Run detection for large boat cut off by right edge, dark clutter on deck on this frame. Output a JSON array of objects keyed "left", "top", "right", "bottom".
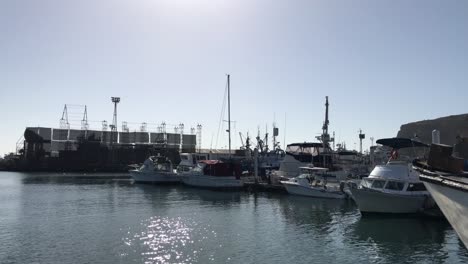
[{"left": 414, "top": 144, "right": 468, "bottom": 248}]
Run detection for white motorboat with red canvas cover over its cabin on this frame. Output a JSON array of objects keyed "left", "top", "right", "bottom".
[{"left": 180, "top": 160, "right": 243, "bottom": 189}]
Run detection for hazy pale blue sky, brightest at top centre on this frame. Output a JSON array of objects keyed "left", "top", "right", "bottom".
[{"left": 0, "top": 0, "right": 468, "bottom": 154}]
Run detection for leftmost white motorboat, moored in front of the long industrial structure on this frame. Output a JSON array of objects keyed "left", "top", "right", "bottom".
[{"left": 129, "top": 156, "right": 181, "bottom": 183}]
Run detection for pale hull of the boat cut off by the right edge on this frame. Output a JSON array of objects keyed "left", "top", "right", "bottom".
[{"left": 424, "top": 178, "right": 468, "bottom": 248}]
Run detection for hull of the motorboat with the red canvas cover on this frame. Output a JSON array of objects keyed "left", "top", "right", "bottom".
[{"left": 182, "top": 175, "right": 244, "bottom": 189}]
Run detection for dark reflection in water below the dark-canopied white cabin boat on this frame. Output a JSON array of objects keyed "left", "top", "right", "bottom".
[{"left": 347, "top": 216, "right": 463, "bottom": 263}]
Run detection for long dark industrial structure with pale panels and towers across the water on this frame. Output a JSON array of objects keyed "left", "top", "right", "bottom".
[{"left": 17, "top": 97, "right": 201, "bottom": 171}]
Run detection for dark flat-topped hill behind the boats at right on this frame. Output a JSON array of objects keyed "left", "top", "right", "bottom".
[{"left": 397, "top": 114, "right": 468, "bottom": 145}]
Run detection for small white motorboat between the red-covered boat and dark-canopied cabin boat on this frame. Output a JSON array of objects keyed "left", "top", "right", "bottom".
[{"left": 281, "top": 167, "right": 347, "bottom": 199}]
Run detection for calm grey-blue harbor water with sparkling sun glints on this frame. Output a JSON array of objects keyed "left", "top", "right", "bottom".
[{"left": 0, "top": 172, "right": 468, "bottom": 263}]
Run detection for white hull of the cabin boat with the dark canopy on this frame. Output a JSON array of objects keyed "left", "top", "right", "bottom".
[{"left": 351, "top": 188, "right": 431, "bottom": 214}]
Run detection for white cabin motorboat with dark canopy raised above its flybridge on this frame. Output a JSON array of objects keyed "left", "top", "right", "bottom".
[{"left": 351, "top": 138, "right": 435, "bottom": 214}]
